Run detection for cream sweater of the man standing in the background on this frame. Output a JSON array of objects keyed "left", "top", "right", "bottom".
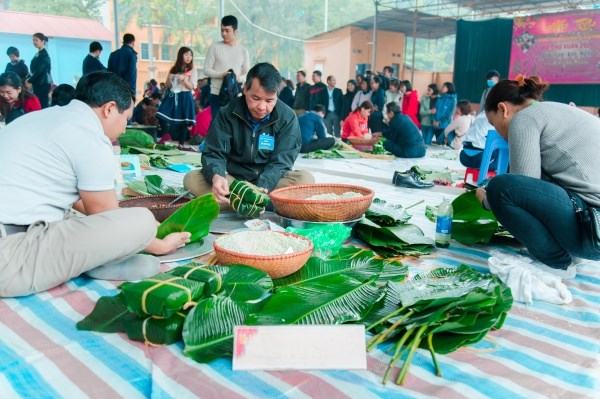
[{"left": 204, "top": 41, "right": 250, "bottom": 95}]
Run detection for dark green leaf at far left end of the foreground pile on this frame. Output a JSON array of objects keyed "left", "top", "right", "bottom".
[{"left": 77, "top": 293, "right": 136, "bottom": 332}]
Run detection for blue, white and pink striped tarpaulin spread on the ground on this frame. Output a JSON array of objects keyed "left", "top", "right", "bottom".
[{"left": 0, "top": 152, "right": 600, "bottom": 399}]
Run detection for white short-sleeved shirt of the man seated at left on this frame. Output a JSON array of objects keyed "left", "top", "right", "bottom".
[{"left": 0, "top": 100, "right": 115, "bottom": 225}]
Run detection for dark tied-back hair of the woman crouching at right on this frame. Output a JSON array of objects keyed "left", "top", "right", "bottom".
[{"left": 485, "top": 75, "right": 550, "bottom": 112}]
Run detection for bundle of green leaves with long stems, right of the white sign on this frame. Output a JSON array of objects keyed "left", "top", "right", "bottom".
[{"left": 365, "top": 265, "right": 513, "bottom": 385}]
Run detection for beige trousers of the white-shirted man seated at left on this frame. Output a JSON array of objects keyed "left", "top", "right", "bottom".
[{"left": 0, "top": 208, "right": 157, "bottom": 297}]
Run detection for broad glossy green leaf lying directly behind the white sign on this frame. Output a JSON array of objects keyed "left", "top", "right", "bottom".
[{"left": 247, "top": 275, "right": 380, "bottom": 325}]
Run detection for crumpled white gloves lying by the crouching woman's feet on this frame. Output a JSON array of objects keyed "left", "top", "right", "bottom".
[{"left": 488, "top": 251, "right": 576, "bottom": 305}]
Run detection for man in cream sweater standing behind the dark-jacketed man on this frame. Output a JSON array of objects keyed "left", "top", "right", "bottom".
[{"left": 204, "top": 15, "right": 250, "bottom": 119}]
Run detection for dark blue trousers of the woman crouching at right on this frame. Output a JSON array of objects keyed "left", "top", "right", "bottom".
[{"left": 486, "top": 174, "right": 600, "bottom": 269}]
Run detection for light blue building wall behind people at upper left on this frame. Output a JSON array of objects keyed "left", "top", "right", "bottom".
[{"left": 0, "top": 33, "right": 111, "bottom": 85}]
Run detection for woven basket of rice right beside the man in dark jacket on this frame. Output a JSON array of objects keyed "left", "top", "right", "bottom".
[{"left": 269, "top": 184, "right": 375, "bottom": 222}]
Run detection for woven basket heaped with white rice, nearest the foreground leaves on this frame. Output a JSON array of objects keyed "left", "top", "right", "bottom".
[{"left": 213, "top": 233, "right": 313, "bottom": 278}]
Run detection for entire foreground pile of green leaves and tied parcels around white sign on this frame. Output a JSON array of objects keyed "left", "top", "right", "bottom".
[{"left": 77, "top": 247, "right": 512, "bottom": 382}]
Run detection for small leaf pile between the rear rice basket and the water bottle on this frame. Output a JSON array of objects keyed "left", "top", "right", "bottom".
[{"left": 352, "top": 198, "right": 434, "bottom": 257}]
